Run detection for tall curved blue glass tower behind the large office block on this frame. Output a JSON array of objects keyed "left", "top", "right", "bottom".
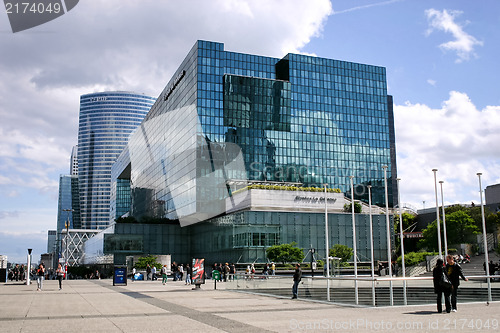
[{"left": 78, "top": 91, "right": 156, "bottom": 229}]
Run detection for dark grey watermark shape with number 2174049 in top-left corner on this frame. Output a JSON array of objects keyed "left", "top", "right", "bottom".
[{"left": 3, "top": 0, "right": 79, "bottom": 33}]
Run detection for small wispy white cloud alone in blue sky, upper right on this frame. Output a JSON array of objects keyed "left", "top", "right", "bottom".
[{"left": 425, "top": 9, "right": 483, "bottom": 63}]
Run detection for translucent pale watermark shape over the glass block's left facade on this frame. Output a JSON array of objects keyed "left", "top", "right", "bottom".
[{"left": 129, "top": 105, "right": 247, "bottom": 226}]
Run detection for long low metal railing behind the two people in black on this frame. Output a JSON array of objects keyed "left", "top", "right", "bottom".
[{"left": 224, "top": 274, "right": 500, "bottom": 307}]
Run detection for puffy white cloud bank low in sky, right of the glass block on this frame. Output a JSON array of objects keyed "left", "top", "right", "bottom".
[{"left": 395, "top": 91, "right": 500, "bottom": 208}]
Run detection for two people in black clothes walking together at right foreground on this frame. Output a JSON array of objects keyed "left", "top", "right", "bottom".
[{"left": 432, "top": 255, "right": 468, "bottom": 313}]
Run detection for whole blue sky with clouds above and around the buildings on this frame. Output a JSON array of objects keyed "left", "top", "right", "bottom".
[{"left": 0, "top": 0, "right": 500, "bottom": 262}]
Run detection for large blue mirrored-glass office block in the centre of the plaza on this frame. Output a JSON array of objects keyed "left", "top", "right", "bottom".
[{"left": 107, "top": 41, "right": 397, "bottom": 261}]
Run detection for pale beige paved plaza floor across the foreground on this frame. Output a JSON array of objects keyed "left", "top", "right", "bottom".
[{"left": 0, "top": 280, "right": 500, "bottom": 332}]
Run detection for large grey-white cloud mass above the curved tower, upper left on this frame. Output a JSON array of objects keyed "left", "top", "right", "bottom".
[{"left": 0, "top": 0, "right": 332, "bottom": 194}]
